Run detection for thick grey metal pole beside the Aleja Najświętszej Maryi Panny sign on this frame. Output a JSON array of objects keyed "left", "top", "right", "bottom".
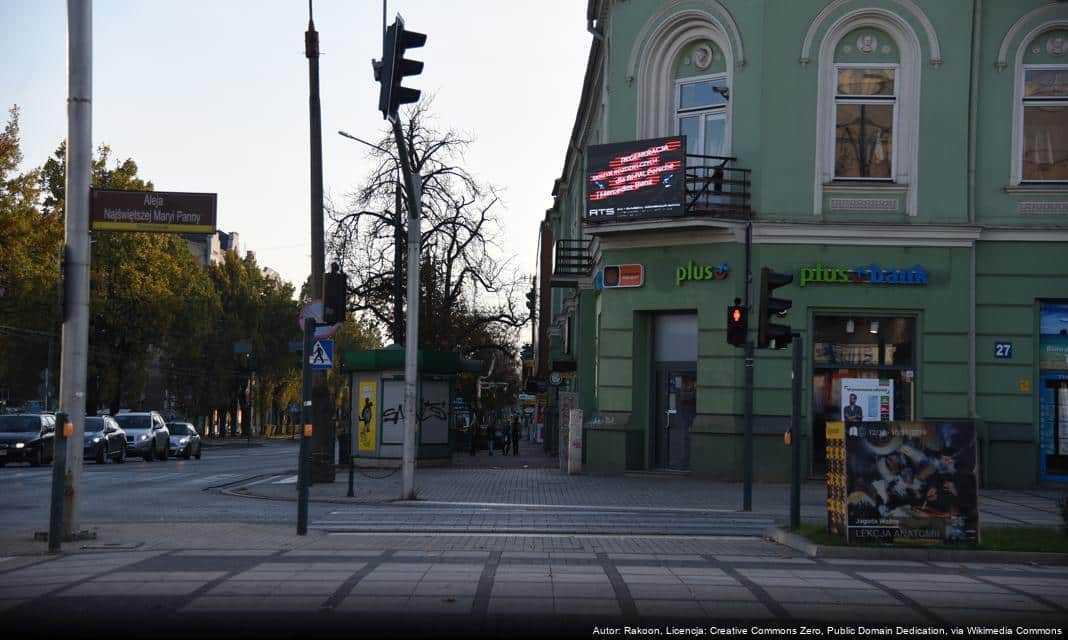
[{"left": 60, "top": 0, "right": 93, "bottom": 537}]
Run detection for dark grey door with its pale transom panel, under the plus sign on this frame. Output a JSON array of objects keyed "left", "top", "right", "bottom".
[{"left": 648, "top": 313, "right": 697, "bottom": 469}]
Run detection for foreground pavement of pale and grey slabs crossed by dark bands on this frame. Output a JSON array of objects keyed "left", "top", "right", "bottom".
[{"left": 0, "top": 529, "right": 1068, "bottom": 637}]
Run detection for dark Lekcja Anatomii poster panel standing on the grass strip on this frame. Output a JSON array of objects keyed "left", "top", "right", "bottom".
[{"left": 844, "top": 422, "right": 979, "bottom": 544}]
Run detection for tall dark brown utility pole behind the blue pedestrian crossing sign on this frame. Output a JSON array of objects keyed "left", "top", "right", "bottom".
[{"left": 303, "top": 0, "right": 334, "bottom": 482}]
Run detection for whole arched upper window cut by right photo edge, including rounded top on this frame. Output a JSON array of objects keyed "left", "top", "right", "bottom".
[{"left": 1014, "top": 29, "right": 1068, "bottom": 183}]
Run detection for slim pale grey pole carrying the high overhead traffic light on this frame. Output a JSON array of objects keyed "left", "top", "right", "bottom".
[{"left": 390, "top": 113, "right": 422, "bottom": 500}]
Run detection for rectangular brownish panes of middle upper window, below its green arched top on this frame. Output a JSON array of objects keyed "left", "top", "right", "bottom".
[{"left": 834, "top": 64, "right": 897, "bottom": 181}]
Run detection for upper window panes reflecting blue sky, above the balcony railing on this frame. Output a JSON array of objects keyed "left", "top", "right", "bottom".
[{"left": 675, "top": 76, "right": 727, "bottom": 161}]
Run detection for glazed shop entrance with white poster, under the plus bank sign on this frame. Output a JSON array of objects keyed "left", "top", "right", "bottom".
[{"left": 812, "top": 315, "right": 916, "bottom": 474}]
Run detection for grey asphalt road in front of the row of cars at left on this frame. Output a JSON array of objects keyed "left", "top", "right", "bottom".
[{"left": 0, "top": 442, "right": 329, "bottom": 531}]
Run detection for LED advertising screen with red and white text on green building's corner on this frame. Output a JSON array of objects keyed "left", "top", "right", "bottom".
[{"left": 586, "top": 136, "right": 686, "bottom": 222}]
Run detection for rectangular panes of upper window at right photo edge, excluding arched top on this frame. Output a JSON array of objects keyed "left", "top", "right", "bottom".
[{"left": 1020, "top": 65, "right": 1068, "bottom": 182}]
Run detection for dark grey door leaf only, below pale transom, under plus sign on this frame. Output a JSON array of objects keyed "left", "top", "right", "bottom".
[{"left": 653, "top": 365, "right": 697, "bottom": 469}]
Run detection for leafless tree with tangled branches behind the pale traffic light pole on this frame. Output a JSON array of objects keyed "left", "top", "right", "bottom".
[{"left": 328, "top": 100, "right": 530, "bottom": 357}]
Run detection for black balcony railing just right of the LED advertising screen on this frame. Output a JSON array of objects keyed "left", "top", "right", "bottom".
[{"left": 686, "top": 154, "right": 752, "bottom": 219}]
